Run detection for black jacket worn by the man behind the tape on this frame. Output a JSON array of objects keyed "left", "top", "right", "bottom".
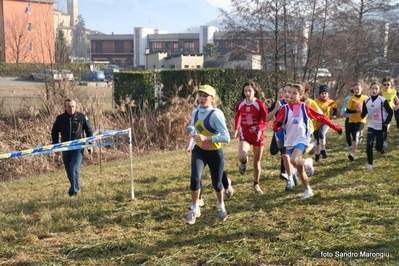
[{"left": 51, "top": 112, "right": 93, "bottom": 144}]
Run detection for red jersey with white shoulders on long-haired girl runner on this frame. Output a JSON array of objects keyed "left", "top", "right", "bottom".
[{"left": 234, "top": 98, "right": 268, "bottom": 134}]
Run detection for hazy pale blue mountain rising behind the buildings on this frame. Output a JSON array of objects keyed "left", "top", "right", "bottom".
[{"left": 78, "top": 0, "right": 225, "bottom": 34}]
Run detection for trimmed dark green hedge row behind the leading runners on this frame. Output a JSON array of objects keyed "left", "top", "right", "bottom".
[{"left": 114, "top": 68, "right": 276, "bottom": 116}]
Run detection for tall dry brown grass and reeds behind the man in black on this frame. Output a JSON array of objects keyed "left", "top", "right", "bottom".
[{"left": 0, "top": 83, "right": 198, "bottom": 181}]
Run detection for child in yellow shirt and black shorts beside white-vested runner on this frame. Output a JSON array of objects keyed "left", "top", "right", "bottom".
[{"left": 346, "top": 83, "right": 367, "bottom": 161}]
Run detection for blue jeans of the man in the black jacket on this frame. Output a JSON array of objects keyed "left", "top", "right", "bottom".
[{"left": 62, "top": 149, "right": 84, "bottom": 196}]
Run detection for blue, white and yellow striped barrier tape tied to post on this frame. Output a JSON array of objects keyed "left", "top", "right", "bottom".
[{"left": 0, "top": 129, "right": 129, "bottom": 160}]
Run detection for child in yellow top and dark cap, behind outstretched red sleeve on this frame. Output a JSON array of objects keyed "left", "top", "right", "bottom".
[{"left": 314, "top": 85, "right": 338, "bottom": 162}]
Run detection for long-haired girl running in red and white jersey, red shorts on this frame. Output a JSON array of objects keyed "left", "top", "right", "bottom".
[{"left": 232, "top": 81, "right": 268, "bottom": 194}]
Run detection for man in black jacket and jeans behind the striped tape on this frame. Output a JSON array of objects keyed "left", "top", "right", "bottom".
[{"left": 51, "top": 99, "right": 93, "bottom": 198}]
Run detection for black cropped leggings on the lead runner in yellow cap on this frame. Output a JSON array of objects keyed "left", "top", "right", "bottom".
[{"left": 190, "top": 146, "right": 227, "bottom": 192}]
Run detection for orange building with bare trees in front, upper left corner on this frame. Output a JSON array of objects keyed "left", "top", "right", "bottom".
[{"left": 0, "top": 0, "right": 55, "bottom": 64}]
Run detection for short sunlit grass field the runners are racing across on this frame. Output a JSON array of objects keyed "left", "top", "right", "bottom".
[{"left": 0, "top": 119, "right": 399, "bottom": 265}]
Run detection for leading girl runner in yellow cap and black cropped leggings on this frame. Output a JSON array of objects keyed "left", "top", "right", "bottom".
[{"left": 186, "top": 85, "right": 230, "bottom": 225}]
